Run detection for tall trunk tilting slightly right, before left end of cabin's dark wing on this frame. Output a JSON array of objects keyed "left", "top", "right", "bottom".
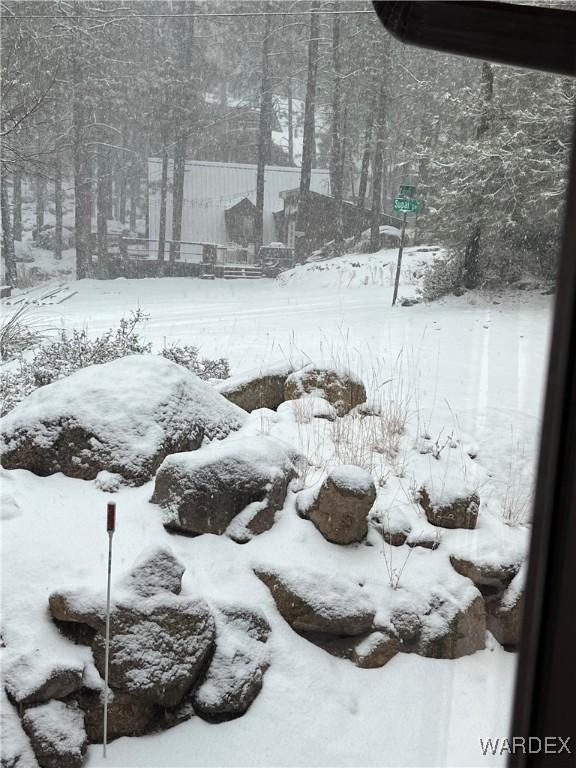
[{"left": 296, "top": 0, "right": 320, "bottom": 259}]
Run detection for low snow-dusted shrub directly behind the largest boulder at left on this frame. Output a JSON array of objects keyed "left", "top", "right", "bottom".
[{"left": 0, "top": 309, "right": 230, "bottom": 415}]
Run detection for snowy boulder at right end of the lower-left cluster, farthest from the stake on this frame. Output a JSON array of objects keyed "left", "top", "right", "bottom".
[{"left": 192, "top": 606, "right": 270, "bottom": 721}]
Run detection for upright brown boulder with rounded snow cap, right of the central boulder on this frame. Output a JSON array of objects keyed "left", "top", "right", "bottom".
[{"left": 307, "top": 465, "right": 376, "bottom": 544}]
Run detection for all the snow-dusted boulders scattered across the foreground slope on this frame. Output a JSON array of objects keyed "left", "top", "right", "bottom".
[{"left": 0, "top": 356, "right": 523, "bottom": 768}]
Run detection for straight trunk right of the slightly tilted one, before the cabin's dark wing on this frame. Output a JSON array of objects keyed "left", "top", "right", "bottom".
[{"left": 330, "top": 4, "right": 344, "bottom": 253}]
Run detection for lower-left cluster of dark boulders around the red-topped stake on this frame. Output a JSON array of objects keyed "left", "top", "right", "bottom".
[{"left": 5, "top": 549, "right": 270, "bottom": 768}]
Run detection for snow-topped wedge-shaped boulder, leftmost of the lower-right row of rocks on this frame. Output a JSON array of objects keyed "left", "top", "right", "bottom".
[{"left": 255, "top": 568, "right": 374, "bottom": 636}]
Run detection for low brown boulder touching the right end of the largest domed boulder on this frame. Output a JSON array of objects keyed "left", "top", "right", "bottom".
[{"left": 216, "top": 362, "right": 294, "bottom": 412}]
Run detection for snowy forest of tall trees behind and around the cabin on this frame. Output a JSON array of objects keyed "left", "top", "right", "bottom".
[{"left": 1, "top": 0, "right": 576, "bottom": 287}]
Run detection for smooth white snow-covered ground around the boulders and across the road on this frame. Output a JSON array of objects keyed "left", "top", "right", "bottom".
[{"left": 2, "top": 248, "right": 552, "bottom": 767}]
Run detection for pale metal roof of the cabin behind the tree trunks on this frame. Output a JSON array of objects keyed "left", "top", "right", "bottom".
[{"left": 148, "top": 158, "right": 330, "bottom": 244}]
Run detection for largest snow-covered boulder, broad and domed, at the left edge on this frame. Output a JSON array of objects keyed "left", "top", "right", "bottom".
[{"left": 0, "top": 355, "right": 246, "bottom": 485}]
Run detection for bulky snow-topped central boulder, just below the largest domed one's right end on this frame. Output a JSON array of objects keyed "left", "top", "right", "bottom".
[{"left": 152, "top": 436, "right": 298, "bottom": 541}]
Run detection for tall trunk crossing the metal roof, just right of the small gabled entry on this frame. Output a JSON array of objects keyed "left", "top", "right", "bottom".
[{"left": 254, "top": 3, "right": 272, "bottom": 256}]
